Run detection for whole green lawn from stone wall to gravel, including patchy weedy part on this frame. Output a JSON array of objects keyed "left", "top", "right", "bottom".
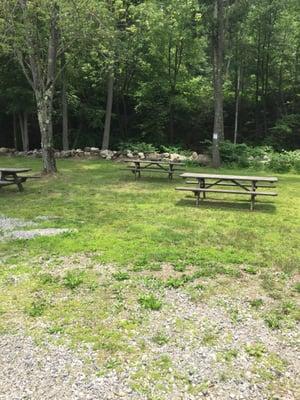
[{"left": 0, "top": 157, "right": 300, "bottom": 398}]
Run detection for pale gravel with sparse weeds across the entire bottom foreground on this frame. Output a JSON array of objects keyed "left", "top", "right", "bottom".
[{"left": 0, "top": 290, "right": 300, "bottom": 400}]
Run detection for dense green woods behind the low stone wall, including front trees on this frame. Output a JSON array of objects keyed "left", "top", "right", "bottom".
[{"left": 0, "top": 0, "right": 300, "bottom": 171}]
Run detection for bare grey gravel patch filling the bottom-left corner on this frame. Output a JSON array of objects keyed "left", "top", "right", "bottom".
[{"left": 0, "top": 335, "right": 137, "bottom": 400}]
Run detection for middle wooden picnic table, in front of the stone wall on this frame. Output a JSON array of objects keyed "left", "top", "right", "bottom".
[{"left": 124, "top": 160, "right": 184, "bottom": 179}]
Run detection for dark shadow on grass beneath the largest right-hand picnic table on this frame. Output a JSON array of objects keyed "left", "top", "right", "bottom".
[{"left": 176, "top": 196, "right": 276, "bottom": 214}]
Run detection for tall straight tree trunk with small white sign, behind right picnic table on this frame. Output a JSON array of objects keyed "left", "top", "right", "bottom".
[{"left": 212, "top": 0, "right": 224, "bottom": 168}]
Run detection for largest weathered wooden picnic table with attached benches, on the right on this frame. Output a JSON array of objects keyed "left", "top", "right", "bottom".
[{"left": 176, "top": 172, "right": 278, "bottom": 211}]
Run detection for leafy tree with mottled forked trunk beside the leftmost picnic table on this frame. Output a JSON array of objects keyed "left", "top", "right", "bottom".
[{"left": 0, "top": 0, "right": 98, "bottom": 173}]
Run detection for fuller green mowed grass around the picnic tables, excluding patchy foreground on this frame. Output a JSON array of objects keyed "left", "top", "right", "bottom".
[{"left": 0, "top": 157, "right": 300, "bottom": 268}]
